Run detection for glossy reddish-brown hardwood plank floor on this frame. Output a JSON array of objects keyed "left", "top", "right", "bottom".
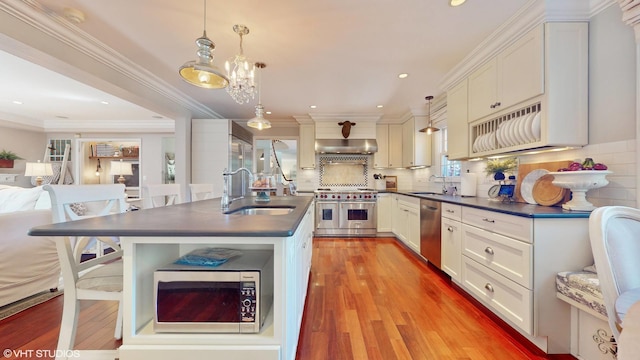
[{"left": 0, "top": 238, "right": 568, "bottom": 360}]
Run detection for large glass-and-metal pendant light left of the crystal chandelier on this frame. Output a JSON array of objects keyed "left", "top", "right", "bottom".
[{"left": 179, "top": 0, "right": 229, "bottom": 89}]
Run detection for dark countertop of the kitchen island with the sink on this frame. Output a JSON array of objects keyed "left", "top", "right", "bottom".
[{"left": 29, "top": 196, "right": 313, "bottom": 237}]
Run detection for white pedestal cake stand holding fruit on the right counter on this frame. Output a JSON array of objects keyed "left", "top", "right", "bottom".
[{"left": 549, "top": 170, "right": 612, "bottom": 211}]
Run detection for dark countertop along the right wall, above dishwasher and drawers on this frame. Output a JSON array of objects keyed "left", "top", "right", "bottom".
[{"left": 379, "top": 191, "right": 591, "bottom": 218}]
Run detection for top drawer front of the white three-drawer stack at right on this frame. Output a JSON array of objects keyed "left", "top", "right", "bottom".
[{"left": 462, "top": 206, "right": 533, "bottom": 243}]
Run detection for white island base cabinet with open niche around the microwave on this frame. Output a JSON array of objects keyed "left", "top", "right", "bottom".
[{"left": 118, "top": 207, "right": 313, "bottom": 360}]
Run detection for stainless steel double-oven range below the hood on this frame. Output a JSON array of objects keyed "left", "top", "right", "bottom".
[{"left": 315, "top": 189, "right": 378, "bottom": 236}]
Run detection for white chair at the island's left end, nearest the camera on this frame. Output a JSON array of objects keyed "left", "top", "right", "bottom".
[{"left": 44, "top": 184, "right": 128, "bottom": 354}]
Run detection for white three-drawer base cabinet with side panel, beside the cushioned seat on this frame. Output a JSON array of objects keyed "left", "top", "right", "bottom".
[{"left": 458, "top": 206, "right": 593, "bottom": 354}]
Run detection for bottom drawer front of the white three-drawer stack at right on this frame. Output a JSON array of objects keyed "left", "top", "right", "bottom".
[{"left": 462, "top": 256, "right": 533, "bottom": 335}]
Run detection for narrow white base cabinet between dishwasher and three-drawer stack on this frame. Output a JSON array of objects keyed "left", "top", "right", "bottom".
[{"left": 441, "top": 203, "right": 462, "bottom": 282}]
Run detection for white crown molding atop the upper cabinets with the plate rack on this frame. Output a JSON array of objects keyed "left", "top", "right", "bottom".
[{"left": 440, "top": 0, "right": 592, "bottom": 92}]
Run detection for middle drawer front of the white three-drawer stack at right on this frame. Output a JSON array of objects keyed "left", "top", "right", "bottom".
[{"left": 462, "top": 224, "right": 533, "bottom": 289}]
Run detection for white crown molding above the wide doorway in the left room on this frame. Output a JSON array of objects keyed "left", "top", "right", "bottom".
[{"left": 43, "top": 119, "right": 175, "bottom": 133}]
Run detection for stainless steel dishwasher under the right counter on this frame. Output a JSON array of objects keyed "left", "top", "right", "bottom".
[{"left": 420, "top": 199, "right": 442, "bottom": 269}]
